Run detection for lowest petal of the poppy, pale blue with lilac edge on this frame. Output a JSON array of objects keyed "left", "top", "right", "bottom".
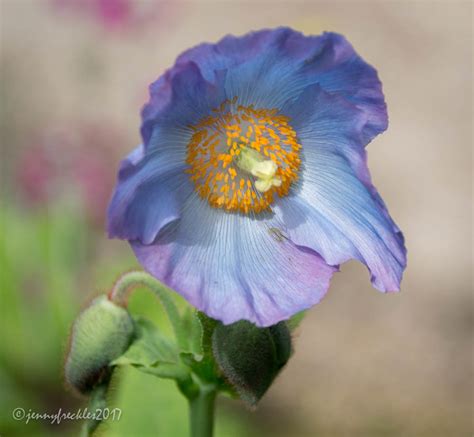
[{"left": 132, "top": 195, "right": 337, "bottom": 326}]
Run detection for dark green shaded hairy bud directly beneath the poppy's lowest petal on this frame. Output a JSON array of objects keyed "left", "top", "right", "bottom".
[{"left": 212, "top": 320, "right": 291, "bottom": 407}]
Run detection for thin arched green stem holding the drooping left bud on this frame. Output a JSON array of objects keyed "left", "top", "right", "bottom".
[{"left": 109, "top": 271, "right": 187, "bottom": 347}]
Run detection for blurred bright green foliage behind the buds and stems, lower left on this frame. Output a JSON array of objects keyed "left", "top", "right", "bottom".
[{"left": 0, "top": 205, "right": 259, "bottom": 437}]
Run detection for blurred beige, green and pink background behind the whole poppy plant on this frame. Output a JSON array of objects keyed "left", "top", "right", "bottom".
[{"left": 0, "top": 0, "right": 474, "bottom": 437}]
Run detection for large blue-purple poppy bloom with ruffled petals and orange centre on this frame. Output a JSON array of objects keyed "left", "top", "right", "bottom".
[{"left": 108, "top": 28, "right": 406, "bottom": 326}]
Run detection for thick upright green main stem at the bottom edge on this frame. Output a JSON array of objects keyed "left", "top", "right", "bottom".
[{"left": 189, "top": 386, "right": 216, "bottom": 437}]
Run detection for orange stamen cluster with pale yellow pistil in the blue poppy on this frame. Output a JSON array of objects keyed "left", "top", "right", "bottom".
[{"left": 186, "top": 97, "right": 301, "bottom": 214}]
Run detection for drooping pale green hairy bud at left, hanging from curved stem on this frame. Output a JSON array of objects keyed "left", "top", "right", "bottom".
[{"left": 65, "top": 295, "right": 134, "bottom": 394}]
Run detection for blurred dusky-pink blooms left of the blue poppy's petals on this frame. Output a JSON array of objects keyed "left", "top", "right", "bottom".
[{"left": 15, "top": 123, "right": 124, "bottom": 225}]
